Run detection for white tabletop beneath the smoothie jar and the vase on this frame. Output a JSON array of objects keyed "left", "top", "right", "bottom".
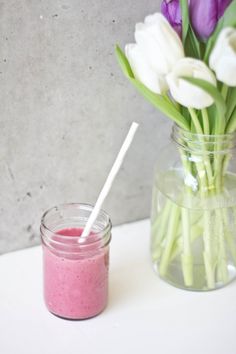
[{"left": 0, "top": 220, "right": 236, "bottom": 354}]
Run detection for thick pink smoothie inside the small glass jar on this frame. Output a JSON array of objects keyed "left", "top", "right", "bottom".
[{"left": 43, "top": 228, "right": 109, "bottom": 319}]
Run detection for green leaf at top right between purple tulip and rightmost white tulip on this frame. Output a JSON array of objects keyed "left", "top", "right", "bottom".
[{"left": 204, "top": 0, "right": 236, "bottom": 63}]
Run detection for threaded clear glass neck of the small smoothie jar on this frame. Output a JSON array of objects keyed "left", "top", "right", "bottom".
[{"left": 40, "top": 203, "right": 112, "bottom": 254}]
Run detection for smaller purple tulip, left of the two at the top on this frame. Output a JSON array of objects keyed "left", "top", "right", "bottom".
[{"left": 161, "top": 0, "right": 182, "bottom": 36}]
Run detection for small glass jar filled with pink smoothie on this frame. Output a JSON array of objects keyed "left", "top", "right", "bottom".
[{"left": 40, "top": 204, "right": 112, "bottom": 320}]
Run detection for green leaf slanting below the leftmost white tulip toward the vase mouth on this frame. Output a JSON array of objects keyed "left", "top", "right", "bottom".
[{"left": 130, "top": 78, "right": 189, "bottom": 130}]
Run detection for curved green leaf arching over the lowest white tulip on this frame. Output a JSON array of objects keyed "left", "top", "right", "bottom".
[{"left": 182, "top": 76, "right": 226, "bottom": 134}]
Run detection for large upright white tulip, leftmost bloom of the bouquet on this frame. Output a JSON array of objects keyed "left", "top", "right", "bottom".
[{"left": 125, "top": 13, "right": 184, "bottom": 94}]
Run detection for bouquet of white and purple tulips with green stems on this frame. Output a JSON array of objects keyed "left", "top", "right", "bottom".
[{"left": 116, "top": 0, "right": 236, "bottom": 290}]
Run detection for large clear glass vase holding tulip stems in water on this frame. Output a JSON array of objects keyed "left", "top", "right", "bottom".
[{"left": 151, "top": 126, "right": 236, "bottom": 290}]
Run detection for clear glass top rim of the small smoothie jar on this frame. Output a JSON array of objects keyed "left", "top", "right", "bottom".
[{"left": 40, "top": 203, "right": 112, "bottom": 247}]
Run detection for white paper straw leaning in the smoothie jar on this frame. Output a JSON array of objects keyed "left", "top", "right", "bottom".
[{"left": 79, "top": 122, "right": 139, "bottom": 242}]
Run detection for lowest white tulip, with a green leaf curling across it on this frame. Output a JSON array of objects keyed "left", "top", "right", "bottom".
[{"left": 166, "top": 58, "right": 216, "bottom": 109}]
